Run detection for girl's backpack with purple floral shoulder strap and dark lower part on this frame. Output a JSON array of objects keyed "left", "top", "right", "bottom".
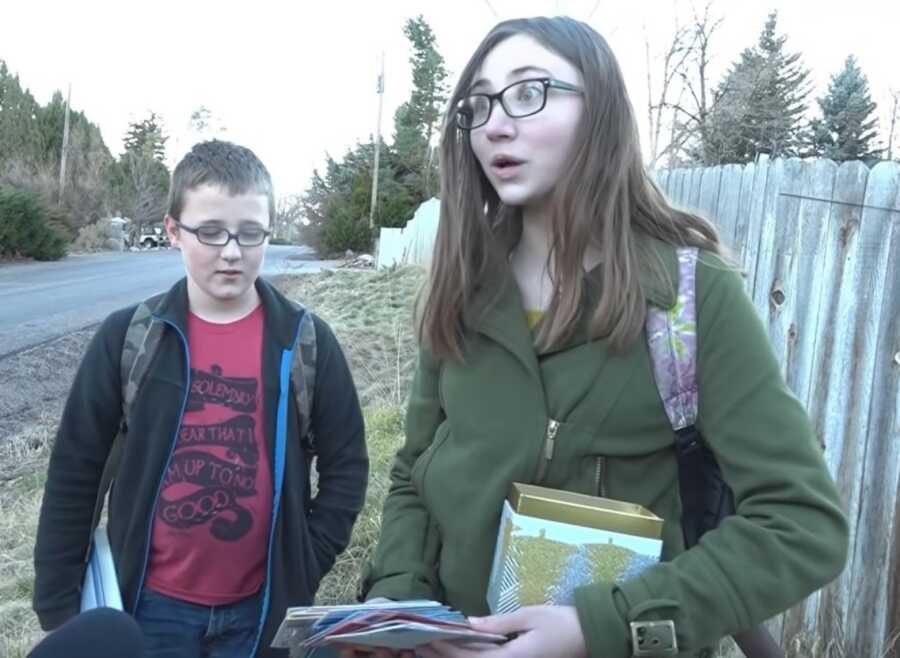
[{"left": 646, "top": 248, "right": 784, "bottom": 658}]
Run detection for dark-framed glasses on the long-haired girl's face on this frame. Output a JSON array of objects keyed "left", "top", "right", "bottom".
[{"left": 456, "top": 78, "right": 584, "bottom": 130}]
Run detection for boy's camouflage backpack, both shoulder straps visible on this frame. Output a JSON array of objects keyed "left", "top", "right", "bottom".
[{"left": 91, "top": 293, "right": 316, "bottom": 532}]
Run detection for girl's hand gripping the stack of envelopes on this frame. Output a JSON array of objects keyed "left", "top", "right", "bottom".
[{"left": 417, "top": 605, "right": 587, "bottom": 658}]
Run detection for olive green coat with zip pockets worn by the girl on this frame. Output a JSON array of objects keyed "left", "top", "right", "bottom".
[{"left": 364, "top": 244, "right": 848, "bottom": 658}]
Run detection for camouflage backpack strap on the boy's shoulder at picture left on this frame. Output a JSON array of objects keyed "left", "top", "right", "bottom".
[{"left": 91, "top": 294, "right": 164, "bottom": 531}]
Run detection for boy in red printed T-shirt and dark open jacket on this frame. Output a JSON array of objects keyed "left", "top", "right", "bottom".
[{"left": 34, "top": 136, "right": 368, "bottom": 658}]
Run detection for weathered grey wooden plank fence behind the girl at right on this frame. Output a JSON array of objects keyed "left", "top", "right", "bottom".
[{"left": 654, "top": 156, "right": 900, "bottom": 658}]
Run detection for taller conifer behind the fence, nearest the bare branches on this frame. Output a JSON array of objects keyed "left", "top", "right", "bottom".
[{"left": 699, "top": 12, "right": 810, "bottom": 165}]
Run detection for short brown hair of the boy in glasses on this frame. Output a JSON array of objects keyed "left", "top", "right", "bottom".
[{"left": 168, "top": 139, "right": 275, "bottom": 222}]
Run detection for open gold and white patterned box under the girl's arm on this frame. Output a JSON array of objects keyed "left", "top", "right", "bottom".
[{"left": 487, "top": 483, "right": 663, "bottom": 614}]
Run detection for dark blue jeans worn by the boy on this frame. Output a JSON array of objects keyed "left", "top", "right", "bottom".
[{"left": 135, "top": 588, "right": 262, "bottom": 658}]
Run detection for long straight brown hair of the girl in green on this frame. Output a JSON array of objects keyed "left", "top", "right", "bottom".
[{"left": 418, "top": 17, "right": 722, "bottom": 359}]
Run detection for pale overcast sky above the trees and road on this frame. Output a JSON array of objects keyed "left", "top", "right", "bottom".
[{"left": 0, "top": 0, "right": 900, "bottom": 194}]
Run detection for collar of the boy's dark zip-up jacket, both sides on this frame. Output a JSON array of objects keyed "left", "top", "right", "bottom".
[{"left": 154, "top": 277, "right": 303, "bottom": 349}]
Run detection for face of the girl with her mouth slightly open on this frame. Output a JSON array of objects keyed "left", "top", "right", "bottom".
[{"left": 469, "top": 34, "right": 584, "bottom": 207}]
